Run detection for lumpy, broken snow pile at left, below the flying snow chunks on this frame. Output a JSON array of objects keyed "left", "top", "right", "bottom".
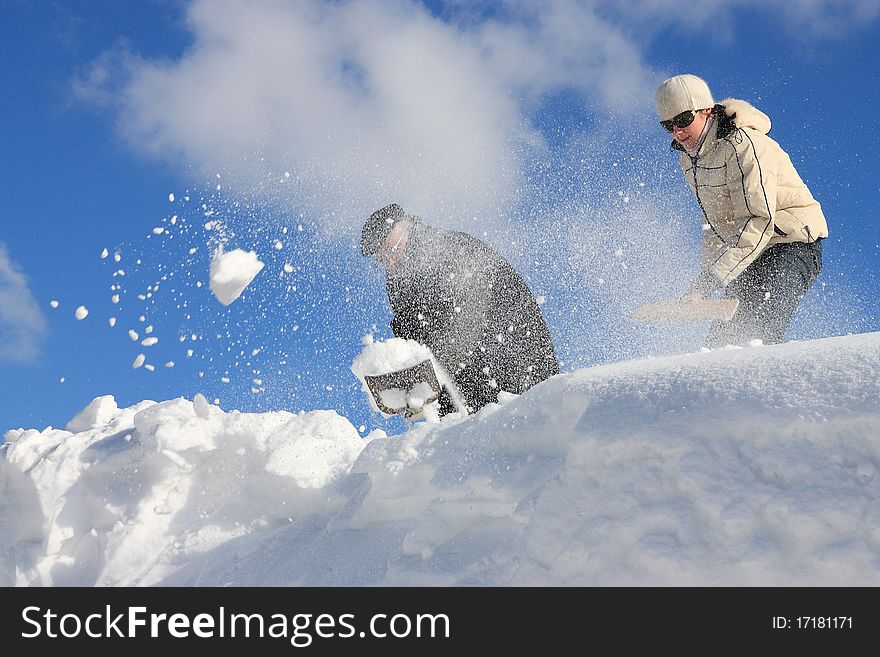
[{"left": 0, "top": 395, "right": 365, "bottom": 586}]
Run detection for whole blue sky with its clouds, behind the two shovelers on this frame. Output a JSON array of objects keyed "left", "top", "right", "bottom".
[{"left": 0, "top": 0, "right": 880, "bottom": 430}]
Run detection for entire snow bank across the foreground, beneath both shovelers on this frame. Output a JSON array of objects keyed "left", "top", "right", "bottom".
[{"left": 0, "top": 333, "right": 880, "bottom": 586}]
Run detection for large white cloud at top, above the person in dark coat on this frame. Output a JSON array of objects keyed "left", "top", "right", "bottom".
[{"left": 79, "top": 0, "right": 651, "bottom": 231}]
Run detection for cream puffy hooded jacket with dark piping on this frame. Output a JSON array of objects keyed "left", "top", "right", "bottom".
[{"left": 673, "top": 99, "right": 828, "bottom": 290}]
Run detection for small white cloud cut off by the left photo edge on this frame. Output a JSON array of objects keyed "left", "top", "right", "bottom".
[{"left": 0, "top": 243, "right": 46, "bottom": 362}]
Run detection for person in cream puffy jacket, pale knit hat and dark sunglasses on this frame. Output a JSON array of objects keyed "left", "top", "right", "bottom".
[{"left": 656, "top": 74, "right": 828, "bottom": 347}]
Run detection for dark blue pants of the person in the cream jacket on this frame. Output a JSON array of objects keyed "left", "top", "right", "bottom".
[{"left": 706, "top": 240, "right": 822, "bottom": 349}]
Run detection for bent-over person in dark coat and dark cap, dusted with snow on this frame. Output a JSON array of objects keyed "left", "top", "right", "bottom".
[{"left": 361, "top": 204, "right": 559, "bottom": 414}]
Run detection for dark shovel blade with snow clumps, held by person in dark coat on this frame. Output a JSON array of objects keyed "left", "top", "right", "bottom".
[{"left": 364, "top": 360, "right": 443, "bottom": 420}]
